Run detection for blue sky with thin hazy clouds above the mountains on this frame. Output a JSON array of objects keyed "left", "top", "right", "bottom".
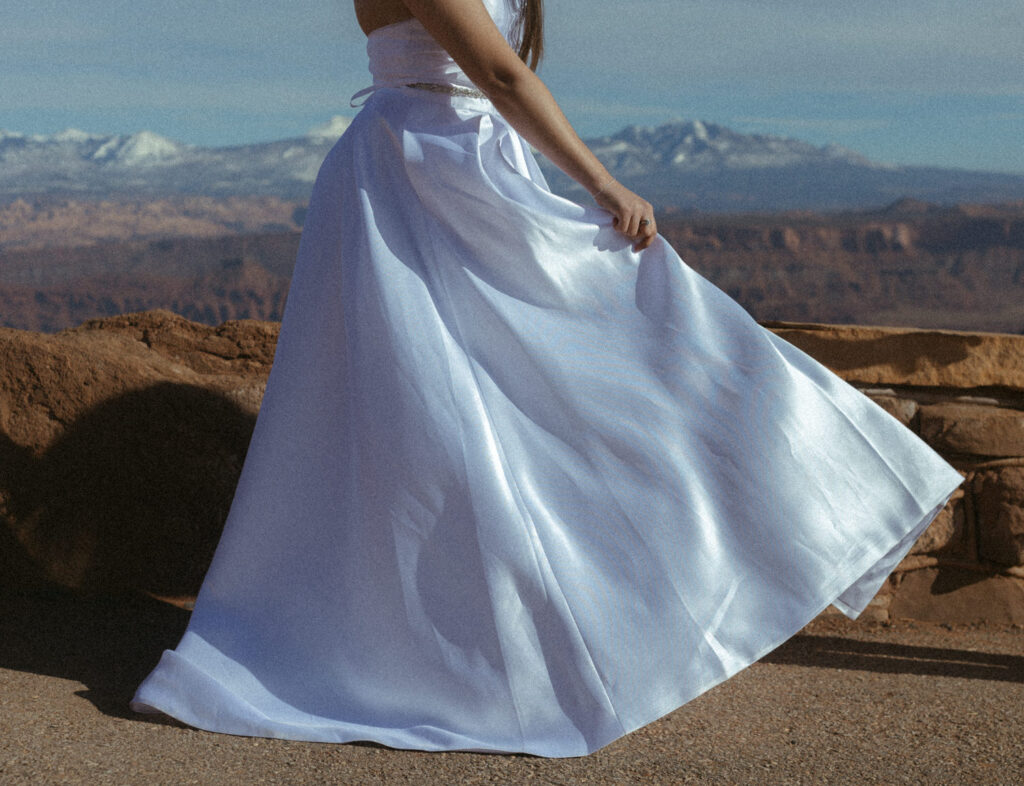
[{"left": 0, "top": 0, "right": 1024, "bottom": 174}]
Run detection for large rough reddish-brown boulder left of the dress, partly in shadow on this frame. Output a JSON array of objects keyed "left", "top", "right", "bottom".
[{"left": 0, "top": 311, "right": 279, "bottom": 596}]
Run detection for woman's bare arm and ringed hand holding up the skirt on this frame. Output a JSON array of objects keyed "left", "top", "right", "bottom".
[{"left": 402, "top": 0, "right": 657, "bottom": 251}]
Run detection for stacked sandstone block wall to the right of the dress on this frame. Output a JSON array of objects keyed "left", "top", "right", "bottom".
[{"left": 769, "top": 323, "right": 1024, "bottom": 623}]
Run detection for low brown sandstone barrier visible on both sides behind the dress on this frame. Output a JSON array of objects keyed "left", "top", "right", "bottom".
[{"left": 0, "top": 311, "right": 1024, "bottom": 623}]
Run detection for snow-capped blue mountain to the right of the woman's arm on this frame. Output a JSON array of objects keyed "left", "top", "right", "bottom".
[{"left": 542, "top": 120, "right": 1024, "bottom": 212}]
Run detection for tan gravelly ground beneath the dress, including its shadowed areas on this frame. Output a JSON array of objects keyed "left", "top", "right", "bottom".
[{"left": 0, "top": 594, "right": 1024, "bottom": 786}]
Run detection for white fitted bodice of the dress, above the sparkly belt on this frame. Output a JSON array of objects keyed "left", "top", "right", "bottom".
[{"left": 352, "top": 0, "right": 519, "bottom": 100}]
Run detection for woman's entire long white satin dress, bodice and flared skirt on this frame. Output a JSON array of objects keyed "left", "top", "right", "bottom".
[{"left": 132, "top": 0, "right": 961, "bottom": 756}]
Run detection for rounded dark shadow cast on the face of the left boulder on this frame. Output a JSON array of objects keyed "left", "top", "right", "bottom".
[{"left": 0, "top": 382, "right": 255, "bottom": 597}]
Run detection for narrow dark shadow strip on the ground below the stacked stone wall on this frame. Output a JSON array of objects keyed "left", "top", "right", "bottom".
[{"left": 764, "top": 634, "right": 1024, "bottom": 683}]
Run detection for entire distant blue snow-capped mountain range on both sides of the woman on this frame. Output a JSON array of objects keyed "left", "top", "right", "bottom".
[{"left": 0, "top": 117, "right": 1024, "bottom": 212}]
